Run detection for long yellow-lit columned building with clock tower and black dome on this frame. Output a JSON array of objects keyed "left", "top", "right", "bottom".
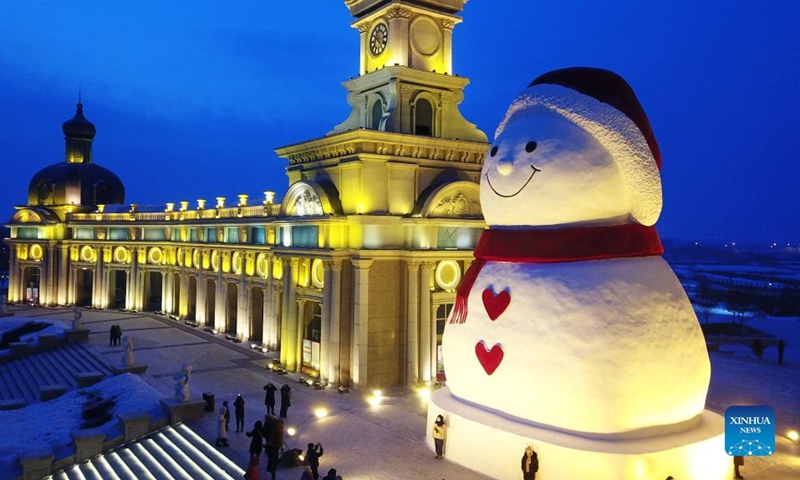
[{"left": 7, "top": 0, "right": 487, "bottom": 387}]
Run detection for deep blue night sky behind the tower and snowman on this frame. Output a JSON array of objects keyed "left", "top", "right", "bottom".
[{"left": 0, "top": 0, "right": 800, "bottom": 244}]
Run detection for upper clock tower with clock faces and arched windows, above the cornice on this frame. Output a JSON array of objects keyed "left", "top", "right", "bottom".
[{"left": 330, "top": 0, "right": 487, "bottom": 142}]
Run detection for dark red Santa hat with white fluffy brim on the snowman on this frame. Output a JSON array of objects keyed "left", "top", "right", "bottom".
[{"left": 495, "top": 67, "right": 662, "bottom": 226}]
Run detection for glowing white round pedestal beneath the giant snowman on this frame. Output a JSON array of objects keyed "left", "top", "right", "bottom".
[{"left": 426, "top": 387, "right": 733, "bottom": 480}]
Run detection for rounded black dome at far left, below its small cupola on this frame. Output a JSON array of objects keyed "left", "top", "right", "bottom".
[{"left": 28, "top": 161, "right": 125, "bottom": 205}]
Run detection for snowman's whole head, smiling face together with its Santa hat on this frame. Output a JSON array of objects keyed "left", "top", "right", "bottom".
[{"left": 481, "top": 68, "right": 661, "bottom": 227}]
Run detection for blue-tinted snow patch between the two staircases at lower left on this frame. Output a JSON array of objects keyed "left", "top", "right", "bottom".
[{"left": 0, "top": 373, "right": 164, "bottom": 478}]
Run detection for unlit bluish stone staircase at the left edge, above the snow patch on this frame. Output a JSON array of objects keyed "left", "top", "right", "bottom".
[{"left": 0, "top": 343, "right": 115, "bottom": 409}]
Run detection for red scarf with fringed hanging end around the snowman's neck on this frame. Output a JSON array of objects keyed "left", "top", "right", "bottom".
[{"left": 450, "top": 224, "right": 664, "bottom": 323}]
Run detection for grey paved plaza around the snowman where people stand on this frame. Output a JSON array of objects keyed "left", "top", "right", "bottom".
[{"left": 8, "top": 306, "right": 800, "bottom": 480}]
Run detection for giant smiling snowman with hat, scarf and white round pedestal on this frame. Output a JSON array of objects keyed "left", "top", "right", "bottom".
[{"left": 428, "top": 68, "right": 731, "bottom": 480}]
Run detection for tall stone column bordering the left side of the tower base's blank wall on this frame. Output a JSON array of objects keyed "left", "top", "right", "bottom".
[{"left": 350, "top": 258, "right": 373, "bottom": 388}]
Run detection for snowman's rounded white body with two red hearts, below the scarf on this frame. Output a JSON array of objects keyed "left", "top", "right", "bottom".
[{"left": 442, "top": 256, "right": 710, "bottom": 434}]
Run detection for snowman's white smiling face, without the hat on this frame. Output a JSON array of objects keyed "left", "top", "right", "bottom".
[{"left": 480, "top": 111, "right": 631, "bottom": 226}]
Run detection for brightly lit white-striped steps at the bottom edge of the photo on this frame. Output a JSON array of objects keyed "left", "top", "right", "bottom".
[{"left": 45, "top": 424, "right": 244, "bottom": 480}]
